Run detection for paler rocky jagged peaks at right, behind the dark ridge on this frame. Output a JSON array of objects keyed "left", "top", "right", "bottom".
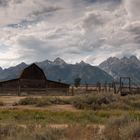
[{"left": 99, "top": 56, "right": 140, "bottom": 84}]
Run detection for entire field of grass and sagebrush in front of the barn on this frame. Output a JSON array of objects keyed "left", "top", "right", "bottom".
[{"left": 0, "top": 94, "right": 140, "bottom": 140}]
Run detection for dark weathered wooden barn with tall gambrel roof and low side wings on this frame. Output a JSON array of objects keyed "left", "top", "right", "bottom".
[{"left": 0, "top": 64, "right": 70, "bottom": 95}]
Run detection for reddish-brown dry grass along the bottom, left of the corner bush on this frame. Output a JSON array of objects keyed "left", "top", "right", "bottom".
[{"left": 0, "top": 124, "right": 101, "bottom": 140}]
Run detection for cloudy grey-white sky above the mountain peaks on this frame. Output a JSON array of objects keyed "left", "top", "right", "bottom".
[{"left": 0, "top": 0, "right": 140, "bottom": 67}]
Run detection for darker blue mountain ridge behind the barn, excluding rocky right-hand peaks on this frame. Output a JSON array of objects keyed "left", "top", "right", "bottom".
[{"left": 0, "top": 58, "right": 113, "bottom": 84}]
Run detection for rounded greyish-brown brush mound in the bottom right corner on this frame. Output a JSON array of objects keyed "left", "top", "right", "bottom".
[{"left": 103, "top": 115, "right": 140, "bottom": 140}]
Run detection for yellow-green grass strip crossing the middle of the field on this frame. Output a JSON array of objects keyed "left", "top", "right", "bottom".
[{"left": 0, "top": 109, "right": 140, "bottom": 125}]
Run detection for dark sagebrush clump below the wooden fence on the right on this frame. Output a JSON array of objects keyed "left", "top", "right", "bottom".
[{"left": 72, "top": 93, "right": 140, "bottom": 110}]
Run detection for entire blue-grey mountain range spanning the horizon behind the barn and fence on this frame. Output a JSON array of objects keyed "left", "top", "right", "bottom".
[{"left": 0, "top": 56, "right": 140, "bottom": 84}]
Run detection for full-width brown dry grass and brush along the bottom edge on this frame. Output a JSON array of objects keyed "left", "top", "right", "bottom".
[{"left": 0, "top": 113, "right": 140, "bottom": 140}]
